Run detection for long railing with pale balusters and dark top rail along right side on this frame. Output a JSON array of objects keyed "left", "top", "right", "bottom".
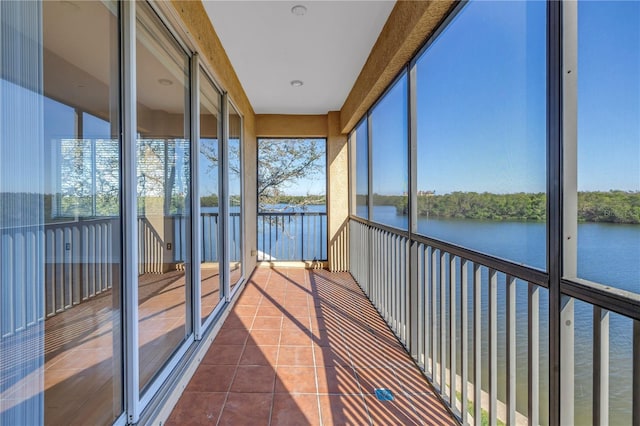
[{"left": 349, "top": 217, "right": 640, "bottom": 425}]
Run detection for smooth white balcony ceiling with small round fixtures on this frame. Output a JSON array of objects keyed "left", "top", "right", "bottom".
[{"left": 203, "top": 0, "right": 395, "bottom": 114}]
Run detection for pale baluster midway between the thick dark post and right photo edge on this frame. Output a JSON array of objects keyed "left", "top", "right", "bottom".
[{"left": 593, "top": 306, "right": 609, "bottom": 425}]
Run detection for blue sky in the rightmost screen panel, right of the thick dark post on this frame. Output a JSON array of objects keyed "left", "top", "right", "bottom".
[{"left": 578, "top": 1, "right": 640, "bottom": 191}]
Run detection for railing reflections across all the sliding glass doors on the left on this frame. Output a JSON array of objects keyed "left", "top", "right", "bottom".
[{"left": 0, "top": 213, "right": 241, "bottom": 336}]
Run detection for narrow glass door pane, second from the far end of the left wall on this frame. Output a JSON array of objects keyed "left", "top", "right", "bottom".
[{"left": 198, "top": 71, "right": 222, "bottom": 321}]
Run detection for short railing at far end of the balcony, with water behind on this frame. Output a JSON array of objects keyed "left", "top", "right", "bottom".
[{"left": 257, "top": 212, "right": 327, "bottom": 261}]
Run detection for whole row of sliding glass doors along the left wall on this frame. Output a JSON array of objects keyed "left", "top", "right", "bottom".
[{"left": 0, "top": 0, "right": 244, "bottom": 425}]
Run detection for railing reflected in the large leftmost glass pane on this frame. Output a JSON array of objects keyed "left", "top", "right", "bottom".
[{"left": 0, "top": 218, "right": 119, "bottom": 337}]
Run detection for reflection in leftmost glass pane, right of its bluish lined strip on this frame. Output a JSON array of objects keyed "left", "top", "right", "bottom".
[{"left": 44, "top": 1, "right": 123, "bottom": 425}]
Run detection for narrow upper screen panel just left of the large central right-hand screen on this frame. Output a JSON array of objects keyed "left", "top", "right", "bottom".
[{"left": 369, "top": 74, "right": 409, "bottom": 229}]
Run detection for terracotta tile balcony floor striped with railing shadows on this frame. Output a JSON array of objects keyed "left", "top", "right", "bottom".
[{"left": 167, "top": 268, "right": 457, "bottom": 426}]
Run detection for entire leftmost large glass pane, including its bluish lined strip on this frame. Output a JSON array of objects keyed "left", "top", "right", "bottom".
[{"left": 0, "top": 1, "right": 123, "bottom": 425}]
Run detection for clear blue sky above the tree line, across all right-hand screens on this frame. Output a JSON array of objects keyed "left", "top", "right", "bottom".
[{"left": 362, "top": 1, "right": 640, "bottom": 194}]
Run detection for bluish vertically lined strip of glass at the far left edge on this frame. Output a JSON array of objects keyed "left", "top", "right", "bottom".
[{"left": 0, "top": 1, "right": 46, "bottom": 425}]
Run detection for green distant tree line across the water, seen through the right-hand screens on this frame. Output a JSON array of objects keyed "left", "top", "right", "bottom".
[{"left": 373, "top": 191, "right": 640, "bottom": 224}]
